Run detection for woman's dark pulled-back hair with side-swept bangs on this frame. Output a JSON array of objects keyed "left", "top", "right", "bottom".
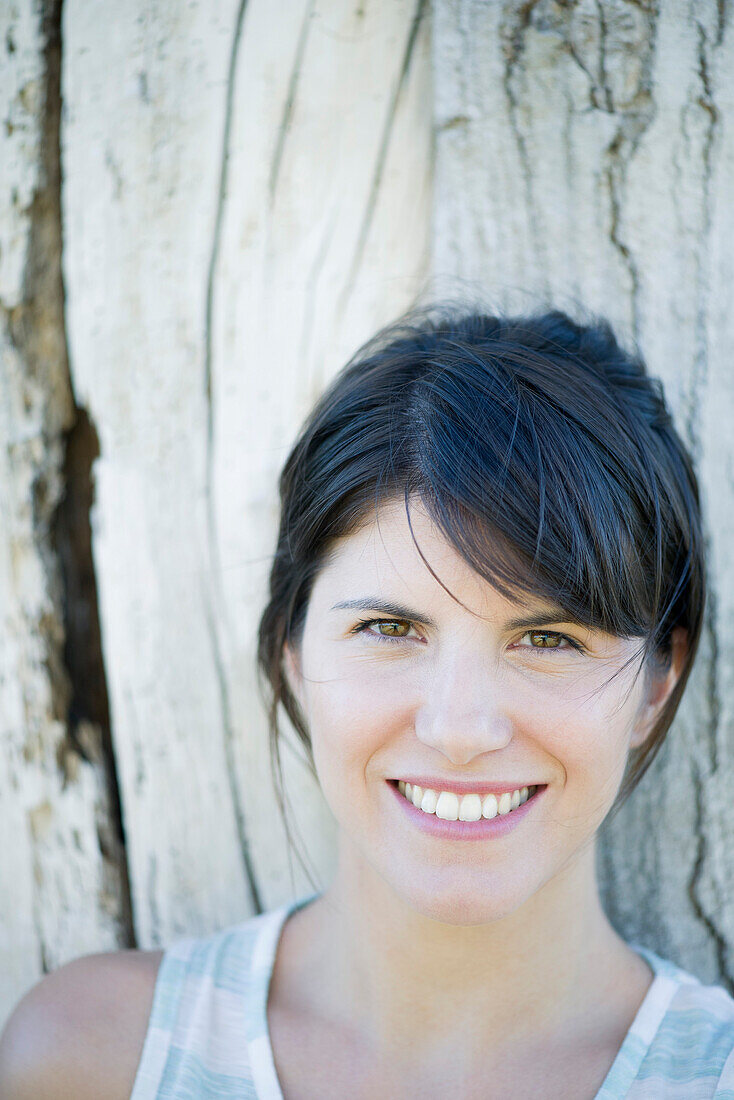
[{"left": 258, "top": 304, "right": 705, "bottom": 875}]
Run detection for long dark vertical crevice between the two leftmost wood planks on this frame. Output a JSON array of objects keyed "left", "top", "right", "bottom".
[{"left": 41, "top": 0, "right": 135, "bottom": 947}]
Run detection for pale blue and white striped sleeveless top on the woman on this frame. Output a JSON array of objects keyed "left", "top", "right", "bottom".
[{"left": 130, "top": 892, "right": 734, "bottom": 1100}]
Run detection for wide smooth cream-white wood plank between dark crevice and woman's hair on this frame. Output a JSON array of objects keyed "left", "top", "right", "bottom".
[{"left": 62, "top": 0, "right": 430, "bottom": 946}]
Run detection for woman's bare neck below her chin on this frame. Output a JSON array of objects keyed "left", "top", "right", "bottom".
[{"left": 294, "top": 846, "right": 634, "bottom": 1057}]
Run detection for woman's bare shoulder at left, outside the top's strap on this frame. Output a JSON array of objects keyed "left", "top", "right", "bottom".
[{"left": 0, "top": 950, "right": 163, "bottom": 1100}]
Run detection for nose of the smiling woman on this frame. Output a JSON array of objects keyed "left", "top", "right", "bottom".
[{"left": 415, "top": 650, "right": 513, "bottom": 766}]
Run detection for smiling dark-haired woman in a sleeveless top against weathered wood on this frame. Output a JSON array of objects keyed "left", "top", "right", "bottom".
[{"left": 0, "top": 309, "right": 734, "bottom": 1100}]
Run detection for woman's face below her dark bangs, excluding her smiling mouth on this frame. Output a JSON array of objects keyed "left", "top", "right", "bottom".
[{"left": 286, "top": 501, "right": 678, "bottom": 924}]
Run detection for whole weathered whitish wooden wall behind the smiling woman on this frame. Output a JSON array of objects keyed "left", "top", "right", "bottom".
[{"left": 5, "top": 0, "right": 734, "bottom": 1023}]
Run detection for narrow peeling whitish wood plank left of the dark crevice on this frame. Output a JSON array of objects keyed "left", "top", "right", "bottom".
[{"left": 0, "top": 3, "right": 124, "bottom": 1022}]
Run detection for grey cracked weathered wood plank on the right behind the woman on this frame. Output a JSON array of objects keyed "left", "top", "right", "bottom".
[{"left": 432, "top": 0, "right": 734, "bottom": 989}]
